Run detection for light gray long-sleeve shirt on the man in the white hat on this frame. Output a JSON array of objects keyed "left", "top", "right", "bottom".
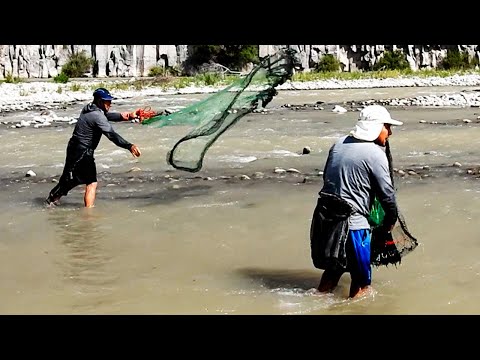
[{"left": 321, "top": 135, "right": 398, "bottom": 230}]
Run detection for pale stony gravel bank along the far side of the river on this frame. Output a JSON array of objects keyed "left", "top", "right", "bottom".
[{"left": 0, "top": 74, "right": 480, "bottom": 114}]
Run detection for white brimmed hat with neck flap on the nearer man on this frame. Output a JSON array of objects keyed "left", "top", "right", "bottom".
[{"left": 350, "top": 105, "right": 403, "bottom": 141}]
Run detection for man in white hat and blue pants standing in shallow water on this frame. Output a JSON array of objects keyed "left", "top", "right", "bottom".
[{"left": 310, "top": 105, "right": 403, "bottom": 298}]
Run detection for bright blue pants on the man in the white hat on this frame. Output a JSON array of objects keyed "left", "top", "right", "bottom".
[{"left": 346, "top": 229, "right": 372, "bottom": 287}]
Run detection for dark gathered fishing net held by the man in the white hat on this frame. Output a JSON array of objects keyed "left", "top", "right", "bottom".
[{"left": 369, "top": 141, "right": 418, "bottom": 266}]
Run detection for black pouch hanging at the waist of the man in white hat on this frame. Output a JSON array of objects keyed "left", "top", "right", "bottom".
[{"left": 310, "top": 193, "right": 356, "bottom": 271}]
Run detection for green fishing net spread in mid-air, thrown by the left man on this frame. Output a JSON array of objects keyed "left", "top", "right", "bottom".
[{"left": 142, "top": 48, "right": 300, "bottom": 172}]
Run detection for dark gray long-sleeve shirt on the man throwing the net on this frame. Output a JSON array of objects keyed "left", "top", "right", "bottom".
[{"left": 72, "top": 103, "right": 132, "bottom": 150}]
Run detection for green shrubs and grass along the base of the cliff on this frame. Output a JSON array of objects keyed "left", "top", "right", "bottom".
[{"left": 31, "top": 45, "right": 480, "bottom": 91}]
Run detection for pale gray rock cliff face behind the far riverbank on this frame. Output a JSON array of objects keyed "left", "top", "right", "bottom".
[{"left": 0, "top": 45, "right": 480, "bottom": 80}]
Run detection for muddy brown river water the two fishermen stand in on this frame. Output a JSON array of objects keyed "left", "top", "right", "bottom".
[{"left": 0, "top": 83, "right": 480, "bottom": 315}]
